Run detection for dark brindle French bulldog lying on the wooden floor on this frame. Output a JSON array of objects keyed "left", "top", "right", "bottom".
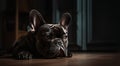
[{"left": 12, "top": 9, "right": 72, "bottom": 59}]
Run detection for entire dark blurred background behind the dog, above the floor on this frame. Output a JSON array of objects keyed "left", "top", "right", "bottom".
[{"left": 0, "top": 0, "right": 120, "bottom": 52}]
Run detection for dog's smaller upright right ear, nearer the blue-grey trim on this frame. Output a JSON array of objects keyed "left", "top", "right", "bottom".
[{"left": 60, "top": 12, "right": 72, "bottom": 29}]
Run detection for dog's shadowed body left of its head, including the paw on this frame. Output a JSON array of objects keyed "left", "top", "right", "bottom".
[{"left": 12, "top": 35, "right": 35, "bottom": 60}]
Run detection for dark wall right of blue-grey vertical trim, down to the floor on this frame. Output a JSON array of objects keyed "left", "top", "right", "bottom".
[{"left": 87, "top": 0, "right": 120, "bottom": 52}]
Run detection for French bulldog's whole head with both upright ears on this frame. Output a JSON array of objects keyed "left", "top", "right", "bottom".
[{"left": 28, "top": 10, "right": 71, "bottom": 57}]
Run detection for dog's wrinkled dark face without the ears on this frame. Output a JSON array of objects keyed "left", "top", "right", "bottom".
[{"left": 36, "top": 24, "right": 68, "bottom": 57}]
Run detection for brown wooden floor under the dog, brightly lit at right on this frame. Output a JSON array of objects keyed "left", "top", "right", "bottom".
[{"left": 0, "top": 53, "right": 120, "bottom": 66}]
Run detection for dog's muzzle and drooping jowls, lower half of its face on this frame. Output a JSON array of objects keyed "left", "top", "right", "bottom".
[{"left": 36, "top": 38, "right": 65, "bottom": 58}]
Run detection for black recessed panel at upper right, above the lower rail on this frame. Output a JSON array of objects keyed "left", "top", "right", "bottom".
[{"left": 93, "top": 0, "right": 120, "bottom": 42}]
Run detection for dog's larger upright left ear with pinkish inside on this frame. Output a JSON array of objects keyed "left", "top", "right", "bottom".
[{"left": 27, "top": 9, "right": 46, "bottom": 32}]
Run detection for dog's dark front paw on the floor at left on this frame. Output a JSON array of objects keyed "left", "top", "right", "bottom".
[{"left": 16, "top": 51, "right": 32, "bottom": 60}]
